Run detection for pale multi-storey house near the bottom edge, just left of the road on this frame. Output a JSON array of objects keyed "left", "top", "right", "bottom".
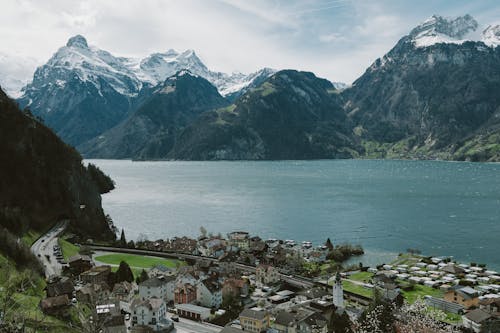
[{"left": 130, "top": 297, "right": 173, "bottom": 332}]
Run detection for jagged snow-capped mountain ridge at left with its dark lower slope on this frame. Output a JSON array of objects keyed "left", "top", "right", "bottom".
[{"left": 18, "top": 35, "right": 274, "bottom": 146}]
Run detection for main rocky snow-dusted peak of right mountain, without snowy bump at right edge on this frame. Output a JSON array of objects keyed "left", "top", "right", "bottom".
[{"left": 409, "top": 14, "right": 479, "bottom": 47}]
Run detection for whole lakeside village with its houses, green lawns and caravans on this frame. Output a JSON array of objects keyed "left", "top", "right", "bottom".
[{"left": 40, "top": 230, "right": 500, "bottom": 333}]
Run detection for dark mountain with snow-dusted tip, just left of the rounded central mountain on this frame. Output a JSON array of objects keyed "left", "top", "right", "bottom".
[{"left": 78, "top": 71, "right": 229, "bottom": 159}]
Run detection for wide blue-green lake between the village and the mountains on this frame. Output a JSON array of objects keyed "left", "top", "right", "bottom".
[{"left": 90, "top": 160, "right": 500, "bottom": 269}]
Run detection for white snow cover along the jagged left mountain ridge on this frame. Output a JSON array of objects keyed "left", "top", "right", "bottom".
[{"left": 20, "top": 35, "right": 275, "bottom": 100}]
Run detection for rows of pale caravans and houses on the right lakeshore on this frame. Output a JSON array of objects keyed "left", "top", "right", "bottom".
[{"left": 364, "top": 257, "right": 500, "bottom": 332}]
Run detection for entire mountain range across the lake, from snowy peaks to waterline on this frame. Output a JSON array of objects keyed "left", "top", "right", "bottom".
[{"left": 8, "top": 15, "right": 500, "bottom": 161}]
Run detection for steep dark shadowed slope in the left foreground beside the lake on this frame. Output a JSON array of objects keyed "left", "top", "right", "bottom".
[{"left": 0, "top": 85, "right": 114, "bottom": 239}]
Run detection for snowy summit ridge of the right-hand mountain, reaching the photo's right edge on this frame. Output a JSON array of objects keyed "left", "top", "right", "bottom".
[{"left": 408, "top": 15, "right": 500, "bottom": 47}]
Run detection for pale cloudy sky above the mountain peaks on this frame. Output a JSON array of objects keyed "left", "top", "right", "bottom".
[{"left": 0, "top": 0, "right": 500, "bottom": 92}]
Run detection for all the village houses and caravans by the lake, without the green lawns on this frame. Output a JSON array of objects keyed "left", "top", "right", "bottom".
[{"left": 40, "top": 231, "right": 500, "bottom": 333}]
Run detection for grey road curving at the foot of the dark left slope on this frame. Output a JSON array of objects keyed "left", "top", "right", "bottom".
[{"left": 31, "top": 221, "right": 69, "bottom": 277}]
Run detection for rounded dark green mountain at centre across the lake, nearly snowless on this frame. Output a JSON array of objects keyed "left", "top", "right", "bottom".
[{"left": 168, "top": 70, "right": 356, "bottom": 160}]
